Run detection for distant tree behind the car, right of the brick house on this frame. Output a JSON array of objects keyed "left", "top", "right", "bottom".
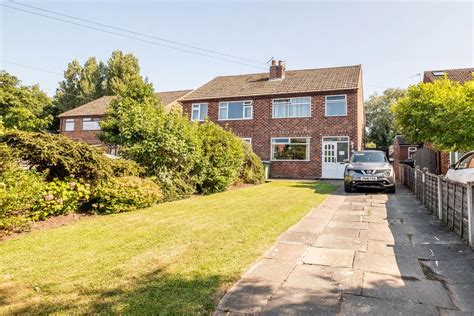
[{"left": 364, "top": 88, "right": 405, "bottom": 148}]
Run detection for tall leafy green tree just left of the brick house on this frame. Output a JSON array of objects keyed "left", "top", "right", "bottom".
[{"left": 99, "top": 77, "right": 201, "bottom": 201}]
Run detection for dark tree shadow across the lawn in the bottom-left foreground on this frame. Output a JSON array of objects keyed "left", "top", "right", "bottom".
[{"left": 5, "top": 270, "right": 229, "bottom": 315}]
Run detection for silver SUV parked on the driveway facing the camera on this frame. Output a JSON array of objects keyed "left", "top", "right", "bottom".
[{"left": 344, "top": 150, "right": 395, "bottom": 193}]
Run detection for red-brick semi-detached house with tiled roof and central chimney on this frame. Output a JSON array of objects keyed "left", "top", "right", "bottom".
[{"left": 181, "top": 60, "right": 365, "bottom": 179}]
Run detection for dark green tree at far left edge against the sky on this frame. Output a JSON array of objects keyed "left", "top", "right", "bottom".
[{"left": 0, "top": 71, "right": 53, "bottom": 131}]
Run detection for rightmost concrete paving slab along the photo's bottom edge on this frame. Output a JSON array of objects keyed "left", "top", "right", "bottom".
[{"left": 340, "top": 294, "right": 437, "bottom": 316}]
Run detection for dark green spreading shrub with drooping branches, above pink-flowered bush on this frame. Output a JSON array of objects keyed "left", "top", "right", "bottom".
[{"left": 0, "top": 130, "right": 138, "bottom": 182}]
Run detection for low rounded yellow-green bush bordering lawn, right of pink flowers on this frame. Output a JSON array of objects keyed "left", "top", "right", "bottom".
[{"left": 91, "top": 176, "right": 162, "bottom": 214}]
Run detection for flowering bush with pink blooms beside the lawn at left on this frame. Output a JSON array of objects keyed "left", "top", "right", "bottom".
[{"left": 29, "top": 177, "right": 90, "bottom": 220}]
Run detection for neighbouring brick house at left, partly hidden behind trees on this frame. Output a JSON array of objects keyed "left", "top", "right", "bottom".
[{"left": 58, "top": 90, "right": 192, "bottom": 154}]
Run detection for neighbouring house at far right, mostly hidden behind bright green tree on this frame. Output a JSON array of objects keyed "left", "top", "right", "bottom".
[{"left": 423, "top": 68, "right": 474, "bottom": 174}]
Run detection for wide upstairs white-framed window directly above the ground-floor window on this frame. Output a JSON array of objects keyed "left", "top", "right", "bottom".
[{"left": 272, "top": 97, "right": 311, "bottom": 118}]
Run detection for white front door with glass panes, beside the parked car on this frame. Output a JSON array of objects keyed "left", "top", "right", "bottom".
[{"left": 321, "top": 136, "right": 349, "bottom": 179}]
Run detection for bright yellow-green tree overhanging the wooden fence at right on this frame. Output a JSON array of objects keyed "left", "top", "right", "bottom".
[{"left": 392, "top": 78, "right": 474, "bottom": 151}]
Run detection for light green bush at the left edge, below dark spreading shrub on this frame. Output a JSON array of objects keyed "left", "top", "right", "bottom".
[{"left": 0, "top": 168, "right": 46, "bottom": 233}]
